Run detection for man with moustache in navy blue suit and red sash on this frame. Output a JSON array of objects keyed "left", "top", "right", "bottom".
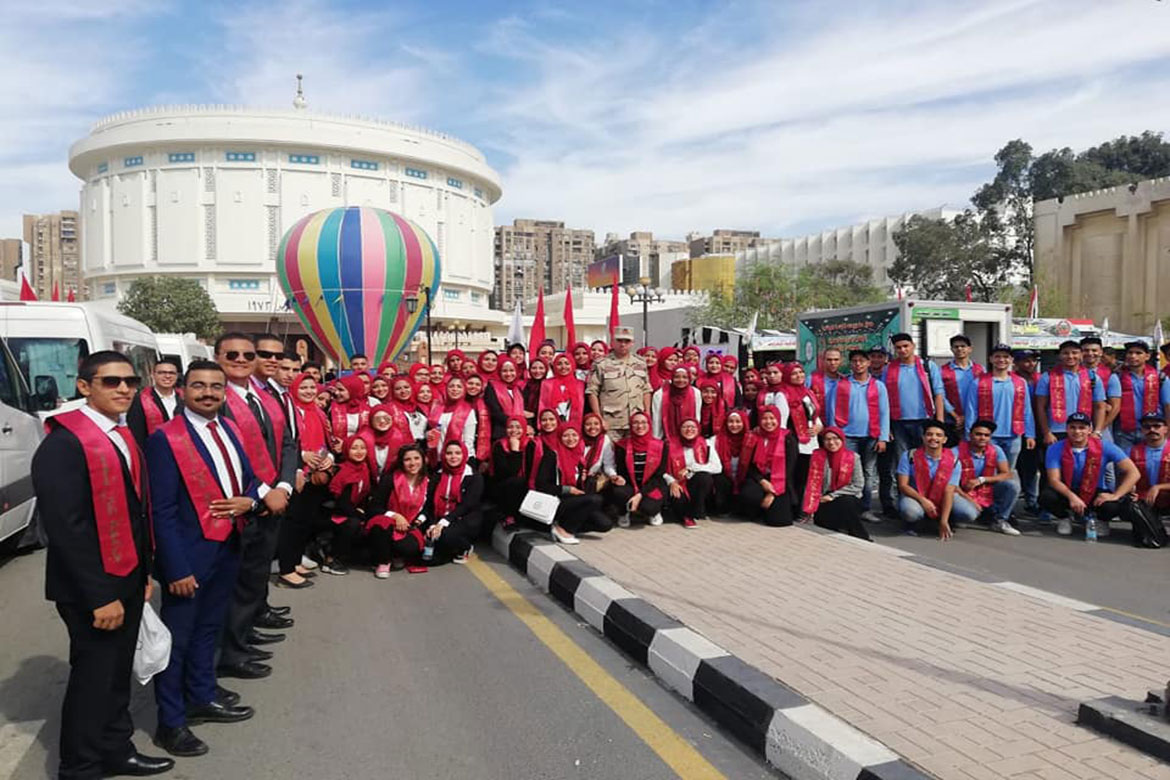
[{"left": 146, "top": 360, "right": 259, "bottom": 755}]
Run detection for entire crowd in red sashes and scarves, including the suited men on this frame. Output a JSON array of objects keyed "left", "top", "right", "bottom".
[{"left": 33, "top": 326, "right": 1170, "bottom": 778}]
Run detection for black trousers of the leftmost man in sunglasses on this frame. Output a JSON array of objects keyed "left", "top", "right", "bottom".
[{"left": 57, "top": 594, "right": 145, "bottom": 780}]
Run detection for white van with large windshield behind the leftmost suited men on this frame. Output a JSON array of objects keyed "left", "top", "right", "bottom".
[{"left": 0, "top": 301, "right": 158, "bottom": 412}]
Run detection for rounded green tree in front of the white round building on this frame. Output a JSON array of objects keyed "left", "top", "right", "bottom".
[{"left": 118, "top": 276, "right": 220, "bottom": 339}]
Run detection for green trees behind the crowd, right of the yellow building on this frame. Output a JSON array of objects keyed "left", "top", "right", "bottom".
[{"left": 690, "top": 260, "right": 886, "bottom": 331}]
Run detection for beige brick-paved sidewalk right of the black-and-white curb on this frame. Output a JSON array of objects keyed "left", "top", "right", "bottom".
[{"left": 572, "top": 522, "right": 1170, "bottom": 780}]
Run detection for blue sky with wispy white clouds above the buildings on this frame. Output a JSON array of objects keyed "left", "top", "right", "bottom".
[{"left": 0, "top": 0, "right": 1170, "bottom": 240}]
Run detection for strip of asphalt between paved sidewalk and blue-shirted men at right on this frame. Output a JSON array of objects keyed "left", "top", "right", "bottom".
[{"left": 868, "top": 518, "right": 1170, "bottom": 628}]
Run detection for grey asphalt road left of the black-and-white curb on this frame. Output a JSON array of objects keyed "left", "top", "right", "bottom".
[{"left": 0, "top": 552, "right": 776, "bottom": 780}]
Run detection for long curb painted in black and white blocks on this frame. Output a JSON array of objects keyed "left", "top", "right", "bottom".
[{"left": 491, "top": 527, "right": 931, "bottom": 780}]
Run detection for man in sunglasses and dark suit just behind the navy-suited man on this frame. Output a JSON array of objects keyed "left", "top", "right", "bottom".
[{"left": 215, "top": 332, "right": 297, "bottom": 679}]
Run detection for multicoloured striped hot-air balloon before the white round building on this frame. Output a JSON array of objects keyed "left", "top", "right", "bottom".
[{"left": 276, "top": 206, "right": 440, "bottom": 366}]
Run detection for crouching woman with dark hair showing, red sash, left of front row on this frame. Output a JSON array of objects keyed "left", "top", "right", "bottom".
[{"left": 366, "top": 444, "right": 428, "bottom": 580}]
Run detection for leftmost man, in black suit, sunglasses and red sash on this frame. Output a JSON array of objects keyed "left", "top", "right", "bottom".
[{"left": 32, "top": 351, "right": 174, "bottom": 780}]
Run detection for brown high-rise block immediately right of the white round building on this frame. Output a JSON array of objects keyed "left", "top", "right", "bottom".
[{"left": 491, "top": 220, "right": 593, "bottom": 311}]
